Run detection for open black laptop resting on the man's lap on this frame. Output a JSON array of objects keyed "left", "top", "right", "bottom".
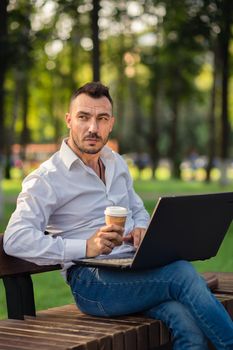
[{"left": 74, "top": 192, "right": 233, "bottom": 269}]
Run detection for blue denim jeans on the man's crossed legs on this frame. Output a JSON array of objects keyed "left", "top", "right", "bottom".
[{"left": 69, "top": 261, "right": 233, "bottom": 350}]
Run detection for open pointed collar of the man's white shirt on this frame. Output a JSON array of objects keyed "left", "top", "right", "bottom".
[{"left": 59, "top": 139, "right": 114, "bottom": 170}]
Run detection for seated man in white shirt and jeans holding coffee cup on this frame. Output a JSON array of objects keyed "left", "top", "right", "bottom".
[{"left": 4, "top": 83, "right": 233, "bottom": 350}]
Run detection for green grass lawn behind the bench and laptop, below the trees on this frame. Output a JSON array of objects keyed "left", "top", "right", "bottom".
[{"left": 0, "top": 180, "right": 233, "bottom": 318}]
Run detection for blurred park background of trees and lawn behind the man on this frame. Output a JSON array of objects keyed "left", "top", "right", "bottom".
[{"left": 0, "top": 0, "right": 233, "bottom": 318}]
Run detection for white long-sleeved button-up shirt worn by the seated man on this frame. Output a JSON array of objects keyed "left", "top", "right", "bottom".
[{"left": 4, "top": 140, "right": 149, "bottom": 269}]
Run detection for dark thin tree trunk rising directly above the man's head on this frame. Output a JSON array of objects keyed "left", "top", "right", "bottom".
[{"left": 92, "top": 0, "right": 100, "bottom": 81}]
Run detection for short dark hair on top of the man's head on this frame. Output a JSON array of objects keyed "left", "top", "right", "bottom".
[{"left": 71, "top": 81, "right": 113, "bottom": 106}]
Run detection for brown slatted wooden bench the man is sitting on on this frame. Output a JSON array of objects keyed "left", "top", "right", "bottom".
[{"left": 0, "top": 236, "right": 233, "bottom": 350}]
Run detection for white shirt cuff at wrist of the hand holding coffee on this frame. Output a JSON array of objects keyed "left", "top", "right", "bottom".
[{"left": 64, "top": 239, "right": 86, "bottom": 262}]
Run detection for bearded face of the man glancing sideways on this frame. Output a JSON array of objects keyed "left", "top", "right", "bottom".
[{"left": 66, "top": 93, "right": 114, "bottom": 154}]
